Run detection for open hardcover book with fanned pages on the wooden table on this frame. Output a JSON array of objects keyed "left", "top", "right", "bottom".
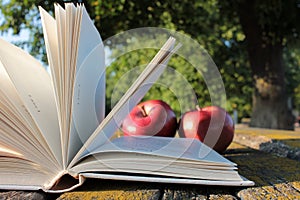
[{"left": 0, "top": 3, "right": 253, "bottom": 192}]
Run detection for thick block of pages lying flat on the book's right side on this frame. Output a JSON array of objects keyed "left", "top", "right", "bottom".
[{"left": 71, "top": 137, "right": 242, "bottom": 181}]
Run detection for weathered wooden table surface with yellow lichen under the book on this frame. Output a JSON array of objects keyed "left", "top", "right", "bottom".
[{"left": 0, "top": 128, "right": 300, "bottom": 200}]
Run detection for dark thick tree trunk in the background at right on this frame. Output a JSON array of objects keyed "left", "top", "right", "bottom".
[{"left": 238, "top": 0, "right": 294, "bottom": 130}]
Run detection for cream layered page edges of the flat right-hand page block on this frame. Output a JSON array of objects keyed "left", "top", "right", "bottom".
[{"left": 74, "top": 159, "right": 242, "bottom": 181}]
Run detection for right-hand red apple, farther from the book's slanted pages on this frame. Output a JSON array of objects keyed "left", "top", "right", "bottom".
[{"left": 178, "top": 106, "right": 234, "bottom": 153}]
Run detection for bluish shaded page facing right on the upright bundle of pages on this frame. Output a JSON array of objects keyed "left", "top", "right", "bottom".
[{"left": 68, "top": 4, "right": 105, "bottom": 164}]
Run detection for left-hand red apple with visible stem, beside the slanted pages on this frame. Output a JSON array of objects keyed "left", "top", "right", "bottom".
[{"left": 121, "top": 100, "right": 177, "bottom": 137}]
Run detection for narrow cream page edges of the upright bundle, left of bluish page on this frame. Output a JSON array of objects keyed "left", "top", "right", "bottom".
[{"left": 55, "top": 3, "right": 80, "bottom": 165}]
